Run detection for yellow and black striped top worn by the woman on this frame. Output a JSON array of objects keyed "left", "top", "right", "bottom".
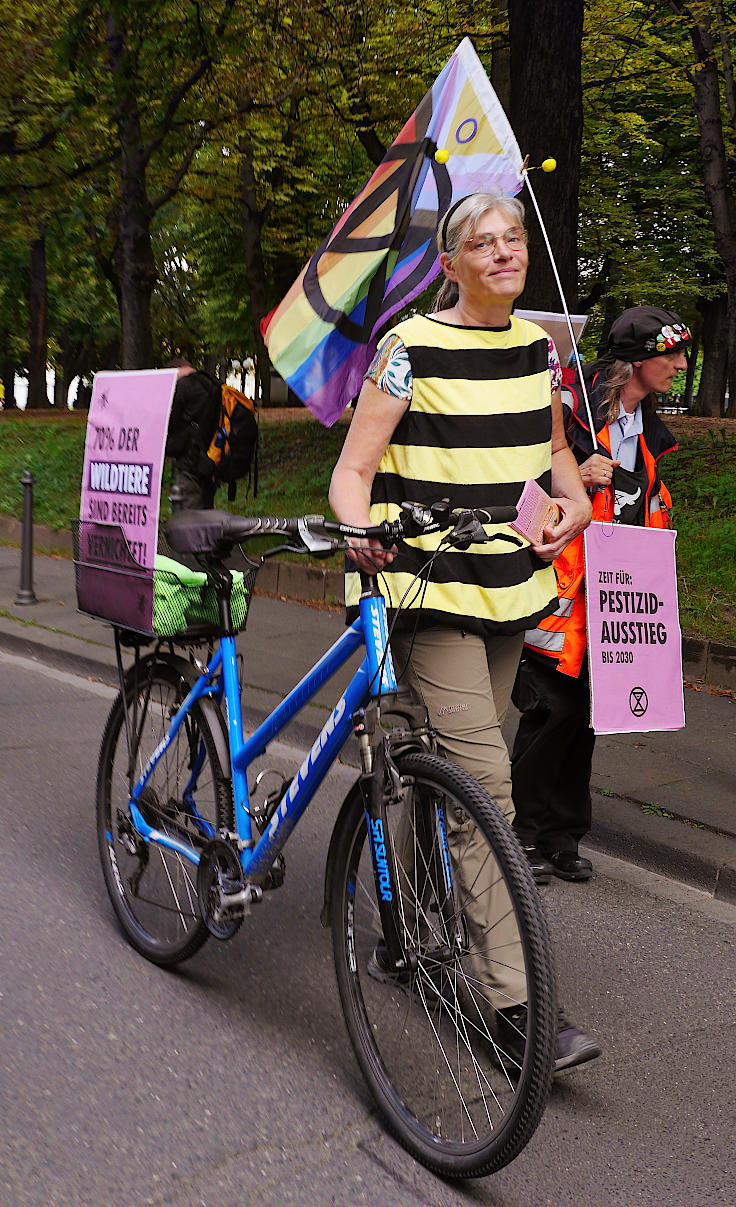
[{"left": 345, "top": 315, "right": 557, "bottom": 632}]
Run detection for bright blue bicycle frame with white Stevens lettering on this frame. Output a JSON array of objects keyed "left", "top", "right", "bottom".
[{"left": 124, "top": 593, "right": 397, "bottom": 885}]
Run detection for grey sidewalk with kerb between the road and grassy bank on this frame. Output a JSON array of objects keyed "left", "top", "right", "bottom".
[{"left": 0, "top": 543, "right": 736, "bottom": 903}]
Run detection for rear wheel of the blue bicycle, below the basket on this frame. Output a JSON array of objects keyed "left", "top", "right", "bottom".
[{"left": 97, "top": 658, "right": 233, "bottom": 966}]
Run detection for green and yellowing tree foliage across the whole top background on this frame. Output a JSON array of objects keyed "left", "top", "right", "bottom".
[{"left": 0, "top": 0, "right": 736, "bottom": 415}]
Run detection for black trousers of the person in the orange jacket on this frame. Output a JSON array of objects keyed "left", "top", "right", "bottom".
[{"left": 512, "top": 651, "right": 595, "bottom": 855}]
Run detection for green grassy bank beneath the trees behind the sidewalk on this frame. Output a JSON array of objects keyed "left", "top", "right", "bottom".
[{"left": 0, "top": 412, "right": 736, "bottom": 642}]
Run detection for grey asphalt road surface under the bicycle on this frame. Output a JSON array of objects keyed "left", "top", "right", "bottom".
[{"left": 0, "top": 655, "right": 736, "bottom": 1207}]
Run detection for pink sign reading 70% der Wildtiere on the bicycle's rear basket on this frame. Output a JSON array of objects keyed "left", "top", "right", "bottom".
[{"left": 77, "top": 369, "right": 176, "bottom": 632}]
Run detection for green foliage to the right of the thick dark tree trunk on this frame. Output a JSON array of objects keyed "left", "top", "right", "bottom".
[{"left": 580, "top": 0, "right": 732, "bottom": 413}]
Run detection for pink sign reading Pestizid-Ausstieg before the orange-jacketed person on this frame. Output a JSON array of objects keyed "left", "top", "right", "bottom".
[{"left": 585, "top": 524, "right": 685, "bottom": 734}]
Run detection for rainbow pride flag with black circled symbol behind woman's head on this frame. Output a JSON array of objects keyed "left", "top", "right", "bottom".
[{"left": 262, "top": 37, "right": 524, "bottom": 426}]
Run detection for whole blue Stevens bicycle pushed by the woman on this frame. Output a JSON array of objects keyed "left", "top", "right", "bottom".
[{"left": 97, "top": 503, "right": 556, "bottom": 1177}]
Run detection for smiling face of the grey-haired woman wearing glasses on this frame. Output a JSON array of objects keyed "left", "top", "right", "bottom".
[{"left": 443, "top": 209, "right": 528, "bottom": 307}]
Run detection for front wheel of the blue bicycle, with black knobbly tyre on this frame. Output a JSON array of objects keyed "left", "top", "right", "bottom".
[{"left": 329, "top": 753, "right": 556, "bottom": 1177}]
